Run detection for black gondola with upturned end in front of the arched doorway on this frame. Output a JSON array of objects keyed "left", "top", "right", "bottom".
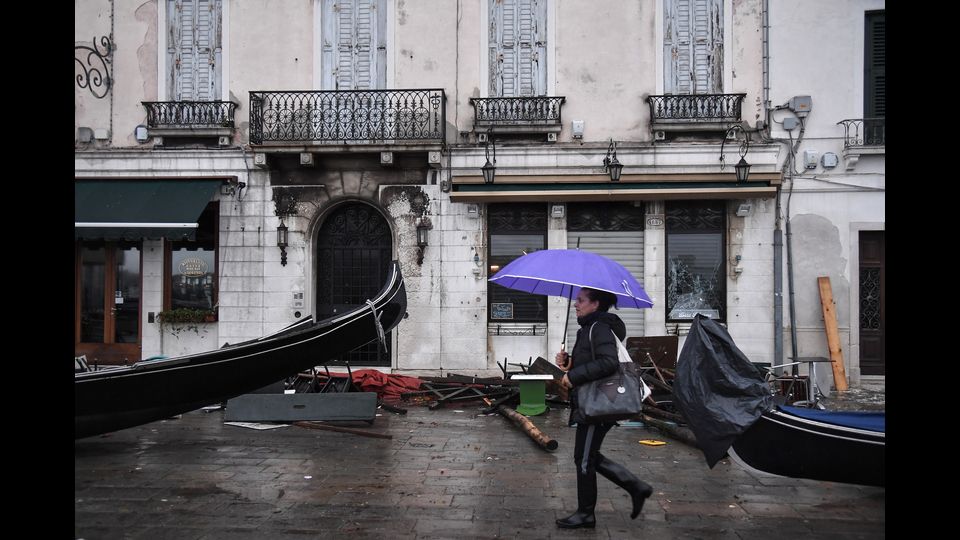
[{"left": 74, "top": 261, "right": 407, "bottom": 439}]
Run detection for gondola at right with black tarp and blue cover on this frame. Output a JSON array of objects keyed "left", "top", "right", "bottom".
[{"left": 673, "top": 315, "right": 886, "bottom": 486}]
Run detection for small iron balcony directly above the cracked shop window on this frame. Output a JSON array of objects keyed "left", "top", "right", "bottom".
[{"left": 646, "top": 94, "right": 746, "bottom": 139}]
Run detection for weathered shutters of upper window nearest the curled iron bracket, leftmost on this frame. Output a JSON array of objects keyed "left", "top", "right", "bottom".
[{"left": 167, "top": 0, "right": 223, "bottom": 101}]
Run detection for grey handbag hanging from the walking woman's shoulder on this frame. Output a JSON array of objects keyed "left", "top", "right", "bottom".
[{"left": 577, "top": 323, "right": 650, "bottom": 423}]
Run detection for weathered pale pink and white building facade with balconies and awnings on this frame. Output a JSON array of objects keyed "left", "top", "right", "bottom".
[{"left": 75, "top": 0, "right": 883, "bottom": 388}]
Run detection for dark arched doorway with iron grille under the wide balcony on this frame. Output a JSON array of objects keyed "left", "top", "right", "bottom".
[{"left": 316, "top": 202, "right": 393, "bottom": 366}]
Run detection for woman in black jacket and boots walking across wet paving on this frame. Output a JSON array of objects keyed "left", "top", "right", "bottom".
[{"left": 556, "top": 287, "right": 653, "bottom": 529}]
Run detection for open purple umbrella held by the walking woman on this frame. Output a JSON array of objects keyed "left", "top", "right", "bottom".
[{"left": 490, "top": 249, "right": 653, "bottom": 350}]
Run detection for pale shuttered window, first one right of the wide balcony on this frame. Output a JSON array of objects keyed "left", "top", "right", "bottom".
[{"left": 488, "top": 0, "right": 547, "bottom": 97}]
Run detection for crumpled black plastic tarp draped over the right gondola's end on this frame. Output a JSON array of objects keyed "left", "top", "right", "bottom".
[{"left": 673, "top": 315, "right": 773, "bottom": 469}]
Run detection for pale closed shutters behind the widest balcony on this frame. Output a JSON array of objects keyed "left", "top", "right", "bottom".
[{"left": 320, "top": 0, "right": 387, "bottom": 90}]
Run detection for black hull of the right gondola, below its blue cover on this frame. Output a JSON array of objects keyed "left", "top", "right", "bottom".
[{"left": 729, "top": 410, "right": 886, "bottom": 486}]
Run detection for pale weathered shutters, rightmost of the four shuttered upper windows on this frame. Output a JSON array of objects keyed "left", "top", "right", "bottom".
[{"left": 663, "top": 0, "right": 723, "bottom": 94}]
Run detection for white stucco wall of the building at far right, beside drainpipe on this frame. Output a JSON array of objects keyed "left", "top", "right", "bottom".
[{"left": 770, "top": 0, "right": 886, "bottom": 384}]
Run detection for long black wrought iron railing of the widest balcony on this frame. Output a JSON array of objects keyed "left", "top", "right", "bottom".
[{"left": 250, "top": 88, "right": 446, "bottom": 144}]
